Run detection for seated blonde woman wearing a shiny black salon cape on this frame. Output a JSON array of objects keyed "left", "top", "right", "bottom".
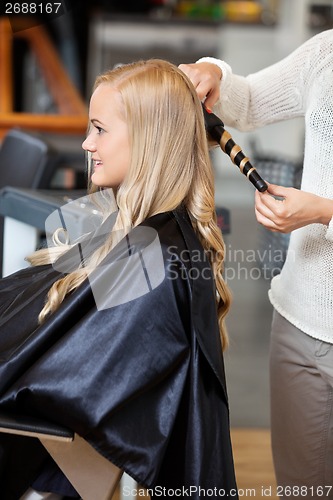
[{"left": 0, "top": 60, "right": 237, "bottom": 500}]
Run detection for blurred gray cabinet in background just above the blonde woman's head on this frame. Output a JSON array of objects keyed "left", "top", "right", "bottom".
[{"left": 87, "top": 14, "right": 220, "bottom": 91}]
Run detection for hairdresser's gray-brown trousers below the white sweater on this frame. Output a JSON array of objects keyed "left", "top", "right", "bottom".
[{"left": 270, "top": 311, "right": 333, "bottom": 500}]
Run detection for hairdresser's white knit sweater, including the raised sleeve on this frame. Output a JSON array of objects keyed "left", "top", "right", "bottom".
[{"left": 198, "top": 30, "right": 333, "bottom": 343}]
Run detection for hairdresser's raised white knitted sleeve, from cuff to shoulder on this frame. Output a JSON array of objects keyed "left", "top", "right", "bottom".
[{"left": 197, "top": 30, "right": 333, "bottom": 131}]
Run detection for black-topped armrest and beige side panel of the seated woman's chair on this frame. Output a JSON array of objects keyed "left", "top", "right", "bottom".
[{"left": 0, "top": 411, "right": 123, "bottom": 500}]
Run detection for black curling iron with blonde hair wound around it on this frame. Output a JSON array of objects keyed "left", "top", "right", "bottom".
[{"left": 202, "top": 105, "right": 268, "bottom": 192}]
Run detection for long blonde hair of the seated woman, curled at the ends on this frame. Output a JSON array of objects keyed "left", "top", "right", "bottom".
[{"left": 30, "top": 59, "right": 230, "bottom": 347}]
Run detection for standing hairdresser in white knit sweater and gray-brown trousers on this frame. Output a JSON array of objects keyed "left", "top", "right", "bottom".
[{"left": 180, "top": 30, "right": 333, "bottom": 499}]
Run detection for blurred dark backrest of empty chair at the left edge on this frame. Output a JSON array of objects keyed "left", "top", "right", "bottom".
[{"left": 0, "top": 129, "right": 57, "bottom": 278}]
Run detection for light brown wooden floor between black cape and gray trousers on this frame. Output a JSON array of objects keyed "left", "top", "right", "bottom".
[{"left": 113, "top": 428, "right": 278, "bottom": 500}]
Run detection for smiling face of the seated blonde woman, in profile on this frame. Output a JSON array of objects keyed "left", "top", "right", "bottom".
[{"left": 82, "top": 83, "right": 130, "bottom": 188}]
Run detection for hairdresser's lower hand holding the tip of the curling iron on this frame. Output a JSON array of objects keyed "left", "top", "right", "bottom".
[{"left": 255, "top": 184, "right": 333, "bottom": 233}]
